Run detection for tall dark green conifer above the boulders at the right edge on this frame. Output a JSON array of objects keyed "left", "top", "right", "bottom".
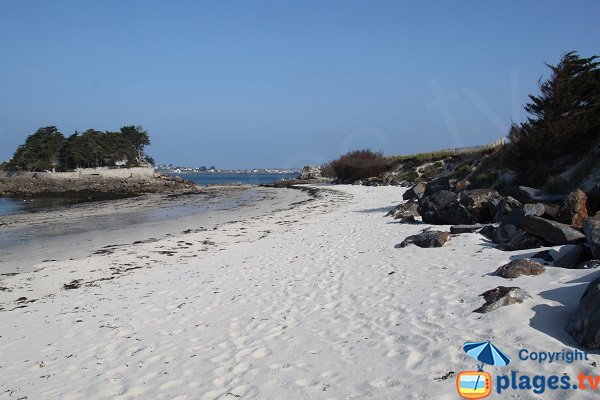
[{"left": 507, "top": 52, "right": 600, "bottom": 185}]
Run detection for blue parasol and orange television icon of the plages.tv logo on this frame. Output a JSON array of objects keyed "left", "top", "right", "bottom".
[{"left": 456, "top": 341, "right": 510, "bottom": 399}]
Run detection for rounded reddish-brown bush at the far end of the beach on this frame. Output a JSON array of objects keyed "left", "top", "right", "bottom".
[{"left": 328, "top": 149, "right": 387, "bottom": 183}]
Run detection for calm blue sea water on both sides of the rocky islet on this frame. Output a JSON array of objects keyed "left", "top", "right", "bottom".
[{"left": 0, "top": 172, "right": 298, "bottom": 216}]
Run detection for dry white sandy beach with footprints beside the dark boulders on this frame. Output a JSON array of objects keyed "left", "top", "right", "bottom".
[{"left": 0, "top": 186, "right": 600, "bottom": 400}]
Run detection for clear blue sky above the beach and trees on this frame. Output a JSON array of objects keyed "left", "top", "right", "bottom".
[{"left": 0, "top": 0, "right": 600, "bottom": 168}]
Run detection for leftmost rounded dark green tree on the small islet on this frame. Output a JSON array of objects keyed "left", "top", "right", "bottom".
[{"left": 8, "top": 126, "right": 65, "bottom": 171}]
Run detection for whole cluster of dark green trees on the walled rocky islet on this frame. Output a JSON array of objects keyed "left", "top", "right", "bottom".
[{"left": 7, "top": 126, "right": 153, "bottom": 171}]
